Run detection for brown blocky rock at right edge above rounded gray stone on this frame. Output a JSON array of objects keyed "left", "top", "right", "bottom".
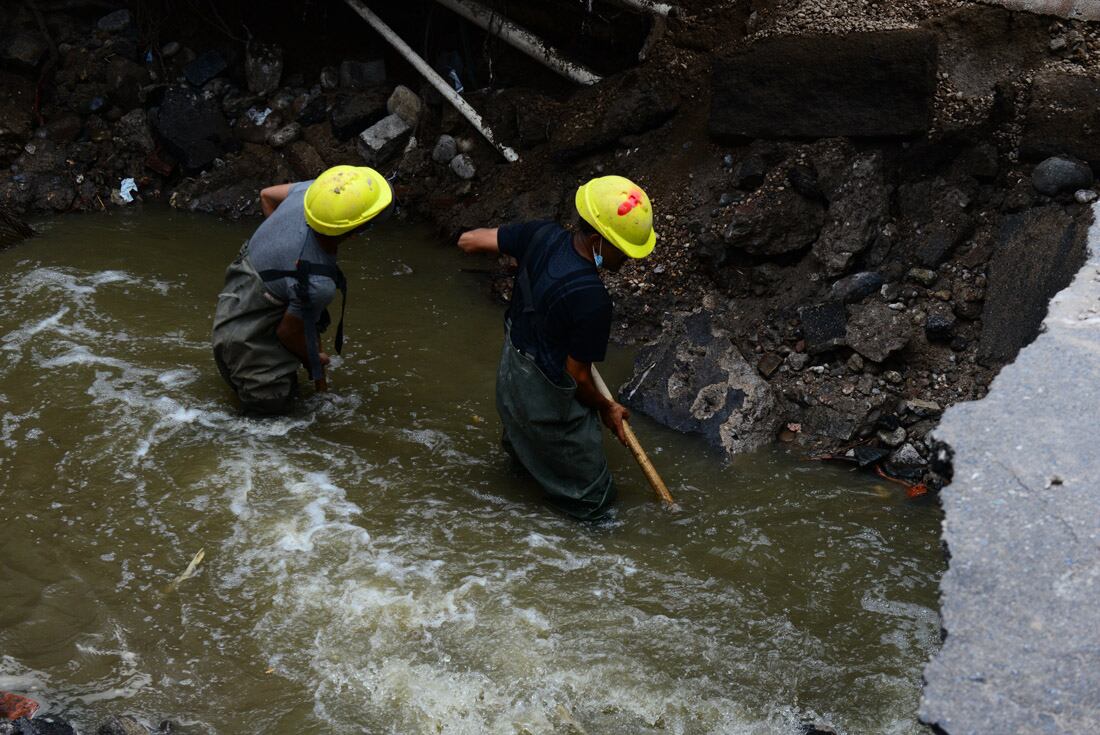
[{"left": 1020, "top": 70, "right": 1100, "bottom": 166}]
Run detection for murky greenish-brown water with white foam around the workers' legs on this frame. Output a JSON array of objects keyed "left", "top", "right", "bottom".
[{"left": 0, "top": 211, "right": 943, "bottom": 734}]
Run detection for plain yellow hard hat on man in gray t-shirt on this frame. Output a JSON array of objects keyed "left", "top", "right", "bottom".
[{"left": 306, "top": 166, "right": 394, "bottom": 235}]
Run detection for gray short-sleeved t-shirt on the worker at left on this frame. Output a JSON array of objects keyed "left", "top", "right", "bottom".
[{"left": 249, "top": 180, "right": 337, "bottom": 319}]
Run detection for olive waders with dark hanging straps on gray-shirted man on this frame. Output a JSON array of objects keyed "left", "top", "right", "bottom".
[{"left": 213, "top": 243, "right": 348, "bottom": 414}]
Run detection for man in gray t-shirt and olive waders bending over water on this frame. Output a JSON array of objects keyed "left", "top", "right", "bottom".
[{"left": 213, "top": 166, "right": 393, "bottom": 415}]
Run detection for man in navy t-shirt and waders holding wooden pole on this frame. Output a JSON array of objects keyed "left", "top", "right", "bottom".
[{"left": 459, "top": 176, "right": 657, "bottom": 519}]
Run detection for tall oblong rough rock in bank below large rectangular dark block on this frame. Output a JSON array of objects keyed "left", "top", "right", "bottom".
[{"left": 813, "top": 153, "right": 892, "bottom": 276}]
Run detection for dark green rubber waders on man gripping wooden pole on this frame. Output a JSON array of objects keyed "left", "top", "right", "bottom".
[{"left": 496, "top": 334, "right": 615, "bottom": 520}]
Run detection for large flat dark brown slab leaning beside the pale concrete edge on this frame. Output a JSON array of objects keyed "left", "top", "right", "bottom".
[{"left": 978, "top": 205, "right": 1086, "bottom": 365}]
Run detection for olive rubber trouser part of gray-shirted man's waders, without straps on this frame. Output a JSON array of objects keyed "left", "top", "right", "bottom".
[{"left": 207, "top": 243, "right": 301, "bottom": 414}]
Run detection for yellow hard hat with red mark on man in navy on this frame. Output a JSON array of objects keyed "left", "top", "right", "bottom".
[{"left": 576, "top": 176, "right": 657, "bottom": 257}]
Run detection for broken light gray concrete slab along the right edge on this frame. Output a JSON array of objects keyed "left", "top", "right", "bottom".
[{"left": 920, "top": 202, "right": 1100, "bottom": 735}]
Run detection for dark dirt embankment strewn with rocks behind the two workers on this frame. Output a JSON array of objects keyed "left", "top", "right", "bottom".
[{"left": 0, "top": 0, "right": 1100, "bottom": 492}]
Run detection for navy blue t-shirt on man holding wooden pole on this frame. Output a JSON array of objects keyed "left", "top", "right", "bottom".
[{"left": 496, "top": 221, "right": 612, "bottom": 383}]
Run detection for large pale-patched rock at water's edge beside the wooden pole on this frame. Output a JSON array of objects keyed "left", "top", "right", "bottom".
[{"left": 623, "top": 311, "right": 782, "bottom": 454}]
